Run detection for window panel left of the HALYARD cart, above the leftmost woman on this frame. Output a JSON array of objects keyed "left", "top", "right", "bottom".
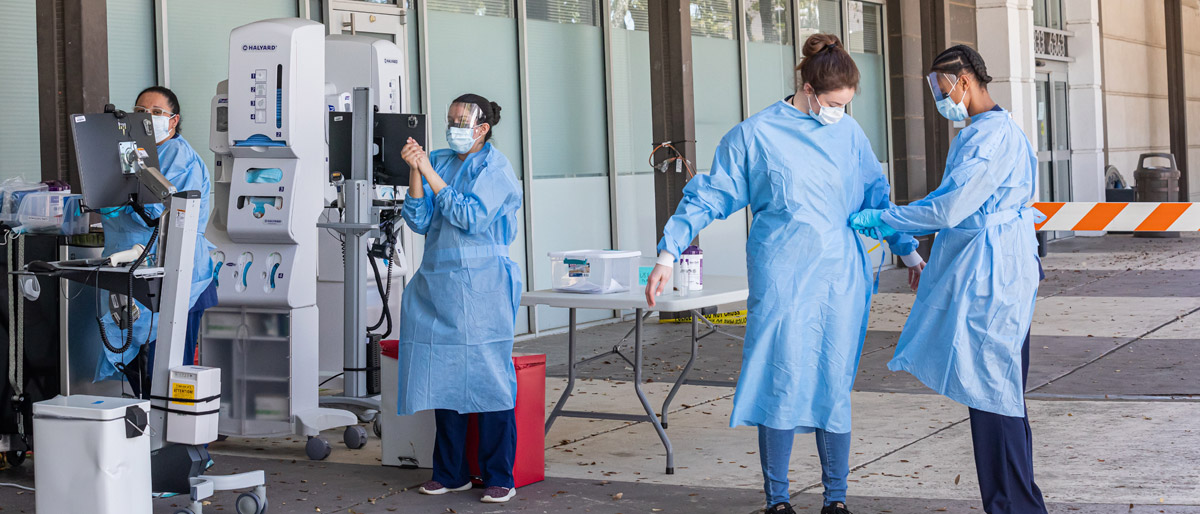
[{"left": 167, "top": 0, "right": 299, "bottom": 169}]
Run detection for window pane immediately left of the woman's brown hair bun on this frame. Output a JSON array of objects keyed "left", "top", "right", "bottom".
[{"left": 745, "top": 0, "right": 796, "bottom": 114}]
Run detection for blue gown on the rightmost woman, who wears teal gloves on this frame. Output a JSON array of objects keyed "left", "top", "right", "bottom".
[{"left": 882, "top": 110, "right": 1039, "bottom": 417}]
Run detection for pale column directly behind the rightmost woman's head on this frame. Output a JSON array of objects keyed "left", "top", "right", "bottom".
[{"left": 976, "top": 0, "right": 1037, "bottom": 141}]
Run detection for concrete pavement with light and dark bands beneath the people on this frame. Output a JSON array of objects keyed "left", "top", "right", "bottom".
[{"left": 0, "top": 235, "right": 1200, "bottom": 514}]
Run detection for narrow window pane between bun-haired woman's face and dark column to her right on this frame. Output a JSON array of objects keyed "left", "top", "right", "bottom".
[{"left": 847, "top": 4, "right": 888, "bottom": 162}]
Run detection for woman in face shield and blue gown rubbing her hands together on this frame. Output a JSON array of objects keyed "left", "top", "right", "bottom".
[{"left": 397, "top": 95, "right": 521, "bottom": 503}]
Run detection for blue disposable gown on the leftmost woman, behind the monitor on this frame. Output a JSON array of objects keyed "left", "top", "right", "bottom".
[{"left": 96, "top": 136, "right": 215, "bottom": 381}]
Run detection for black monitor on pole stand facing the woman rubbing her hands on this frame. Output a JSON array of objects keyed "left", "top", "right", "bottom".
[{"left": 329, "top": 112, "right": 430, "bottom": 186}]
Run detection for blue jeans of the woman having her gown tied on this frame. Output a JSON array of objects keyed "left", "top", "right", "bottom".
[{"left": 758, "top": 425, "right": 850, "bottom": 507}]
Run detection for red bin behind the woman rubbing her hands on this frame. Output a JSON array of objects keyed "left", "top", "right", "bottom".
[{"left": 467, "top": 354, "right": 546, "bottom": 488}]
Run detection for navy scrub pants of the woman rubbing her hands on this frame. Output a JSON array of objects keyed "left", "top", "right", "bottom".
[{"left": 432, "top": 408, "right": 517, "bottom": 489}]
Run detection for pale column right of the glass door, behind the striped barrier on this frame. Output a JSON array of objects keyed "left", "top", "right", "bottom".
[{"left": 1062, "top": 0, "right": 1104, "bottom": 202}]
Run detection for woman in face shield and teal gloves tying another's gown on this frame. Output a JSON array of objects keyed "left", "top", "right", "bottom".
[{"left": 851, "top": 46, "right": 1046, "bottom": 514}]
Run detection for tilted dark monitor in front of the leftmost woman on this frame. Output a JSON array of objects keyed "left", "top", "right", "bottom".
[{"left": 70, "top": 110, "right": 162, "bottom": 209}]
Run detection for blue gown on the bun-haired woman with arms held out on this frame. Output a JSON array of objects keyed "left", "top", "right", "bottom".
[{"left": 659, "top": 101, "right": 917, "bottom": 434}]
